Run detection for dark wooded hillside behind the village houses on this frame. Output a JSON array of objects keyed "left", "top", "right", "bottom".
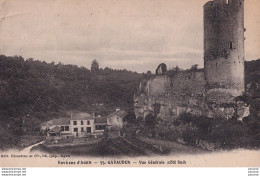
[{"left": 0, "top": 55, "right": 143, "bottom": 148}]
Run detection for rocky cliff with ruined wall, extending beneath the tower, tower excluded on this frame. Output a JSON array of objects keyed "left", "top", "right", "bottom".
[{"left": 134, "top": 70, "right": 249, "bottom": 120}]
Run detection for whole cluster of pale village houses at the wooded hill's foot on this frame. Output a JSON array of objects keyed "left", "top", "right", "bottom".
[{"left": 41, "top": 109, "right": 128, "bottom": 137}]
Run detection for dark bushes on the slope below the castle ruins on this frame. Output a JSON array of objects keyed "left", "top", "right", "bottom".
[{"left": 159, "top": 113, "right": 260, "bottom": 149}]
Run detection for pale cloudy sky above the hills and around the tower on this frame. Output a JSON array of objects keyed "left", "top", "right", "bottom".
[{"left": 0, "top": 0, "right": 260, "bottom": 73}]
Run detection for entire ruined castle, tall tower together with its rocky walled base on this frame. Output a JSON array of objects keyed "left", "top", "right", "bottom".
[{"left": 134, "top": 0, "right": 249, "bottom": 120}]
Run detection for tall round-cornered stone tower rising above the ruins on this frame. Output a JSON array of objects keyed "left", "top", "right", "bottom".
[{"left": 204, "top": 0, "right": 245, "bottom": 103}]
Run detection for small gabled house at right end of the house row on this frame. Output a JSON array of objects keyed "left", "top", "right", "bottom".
[{"left": 107, "top": 109, "right": 128, "bottom": 129}]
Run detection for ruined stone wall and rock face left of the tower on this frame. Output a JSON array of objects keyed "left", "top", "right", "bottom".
[{"left": 134, "top": 71, "right": 205, "bottom": 119}]
